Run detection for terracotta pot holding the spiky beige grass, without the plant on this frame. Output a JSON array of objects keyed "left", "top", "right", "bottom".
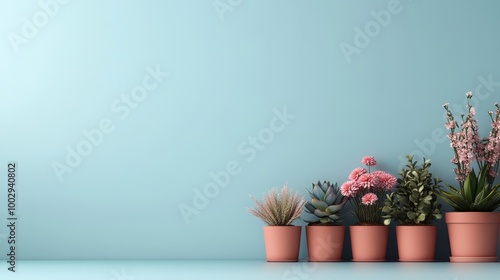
[{"left": 264, "top": 226, "right": 302, "bottom": 262}]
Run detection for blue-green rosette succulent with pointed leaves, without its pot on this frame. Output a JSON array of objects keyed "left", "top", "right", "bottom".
[{"left": 304, "top": 181, "right": 348, "bottom": 225}]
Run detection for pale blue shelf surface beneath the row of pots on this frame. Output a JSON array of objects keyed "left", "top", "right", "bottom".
[{"left": 0, "top": 260, "right": 500, "bottom": 280}]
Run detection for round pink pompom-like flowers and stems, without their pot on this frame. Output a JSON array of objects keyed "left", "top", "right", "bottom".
[{"left": 340, "top": 156, "right": 397, "bottom": 225}]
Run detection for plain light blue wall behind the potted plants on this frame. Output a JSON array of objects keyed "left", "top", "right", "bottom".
[{"left": 0, "top": 0, "right": 500, "bottom": 260}]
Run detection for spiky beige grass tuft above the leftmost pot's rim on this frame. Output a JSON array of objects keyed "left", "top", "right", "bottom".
[{"left": 248, "top": 184, "right": 306, "bottom": 226}]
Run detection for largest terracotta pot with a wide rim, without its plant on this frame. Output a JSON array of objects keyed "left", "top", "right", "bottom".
[{"left": 445, "top": 212, "right": 500, "bottom": 262}]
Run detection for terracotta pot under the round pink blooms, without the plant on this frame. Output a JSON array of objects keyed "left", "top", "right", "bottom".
[{"left": 349, "top": 226, "right": 389, "bottom": 262}]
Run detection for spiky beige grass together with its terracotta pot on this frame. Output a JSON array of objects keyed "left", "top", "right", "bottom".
[{"left": 248, "top": 184, "right": 306, "bottom": 262}]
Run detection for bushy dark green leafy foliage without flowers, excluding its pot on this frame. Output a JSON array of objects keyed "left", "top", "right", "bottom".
[{"left": 382, "top": 155, "right": 442, "bottom": 225}]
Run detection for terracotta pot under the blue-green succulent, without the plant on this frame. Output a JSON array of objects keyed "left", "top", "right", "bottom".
[{"left": 306, "top": 225, "right": 345, "bottom": 262}]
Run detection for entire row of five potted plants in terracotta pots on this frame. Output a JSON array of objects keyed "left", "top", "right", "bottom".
[{"left": 249, "top": 92, "right": 500, "bottom": 262}]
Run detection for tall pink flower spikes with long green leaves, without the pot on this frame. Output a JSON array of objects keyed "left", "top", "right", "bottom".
[{"left": 440, "top": 92, "right": 500, "bottom": 212}]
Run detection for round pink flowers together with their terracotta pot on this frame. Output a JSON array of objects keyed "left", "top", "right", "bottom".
[{"left": 340, "top": 156, "right": 397, "bottom": 261}]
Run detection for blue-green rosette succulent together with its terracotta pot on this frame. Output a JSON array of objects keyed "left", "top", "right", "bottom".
[{"left": 304, "top": 181, "right": 347, "bottom": 262}]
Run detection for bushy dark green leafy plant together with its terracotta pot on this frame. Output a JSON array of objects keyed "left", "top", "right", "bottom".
[{"left": 382, "top": 155, "right": 442, "bottom": 262}]
